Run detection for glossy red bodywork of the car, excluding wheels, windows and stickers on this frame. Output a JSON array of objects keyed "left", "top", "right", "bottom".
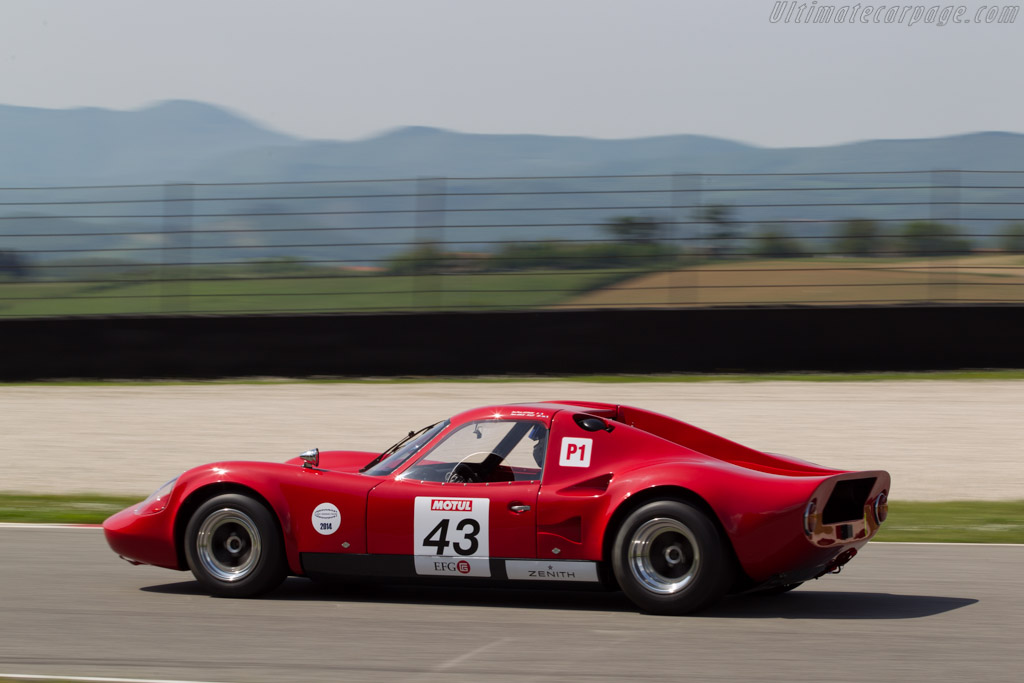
[{"left": 103, "top": 401, "right": 890, "bottom": 590}]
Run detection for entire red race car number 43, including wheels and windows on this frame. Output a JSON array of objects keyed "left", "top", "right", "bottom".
[{"left": 103, "top": 401, "right": 889, "bottom": 613}]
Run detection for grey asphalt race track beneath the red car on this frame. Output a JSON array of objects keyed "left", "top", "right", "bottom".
[{"left": 0, "top": 526, "right": 1024, "bottom": 683}]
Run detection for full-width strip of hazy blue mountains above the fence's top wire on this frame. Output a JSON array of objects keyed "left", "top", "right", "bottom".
[{"left": 0, "top": 100, "right": 1024, "bottom": 186}]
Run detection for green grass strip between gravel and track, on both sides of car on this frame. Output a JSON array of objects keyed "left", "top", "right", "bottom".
[{"left": 0, "top": 494, "right": 1024, "bottom": 544}]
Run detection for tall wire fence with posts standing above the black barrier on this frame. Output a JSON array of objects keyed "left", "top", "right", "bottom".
[{"left": 0, "top": 170, "right": 1024, "bottom": 317}]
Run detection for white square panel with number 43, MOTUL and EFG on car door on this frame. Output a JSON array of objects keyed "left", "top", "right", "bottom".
[{"left": 413, "top": 496, "right": 490, "bottom": 577}]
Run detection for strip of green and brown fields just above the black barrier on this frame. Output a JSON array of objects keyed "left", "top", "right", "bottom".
[{"left": 0, "top": 254, "right": 1024, "bottom": 317}]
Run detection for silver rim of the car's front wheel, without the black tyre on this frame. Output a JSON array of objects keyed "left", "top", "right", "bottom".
[{"left": 196, "top": 508, "right": 262, "bottom": 583}]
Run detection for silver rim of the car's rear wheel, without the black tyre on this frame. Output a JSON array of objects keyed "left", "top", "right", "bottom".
[{"left": 629, "top": 517, "right": 700, "bottom": 595}]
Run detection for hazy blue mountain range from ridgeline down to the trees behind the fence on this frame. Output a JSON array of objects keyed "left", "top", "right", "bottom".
[{"left": 0, "top": 101, "right": 1024, "bottom": 268}]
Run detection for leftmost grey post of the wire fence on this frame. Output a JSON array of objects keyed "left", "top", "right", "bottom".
[{"left": 160, "top": 182, "right": 193, "bottom": 314}]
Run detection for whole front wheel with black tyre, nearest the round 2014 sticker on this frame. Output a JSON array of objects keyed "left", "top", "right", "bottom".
[{"left": 185, "top": 494, "right": 288, "bottom": 598}]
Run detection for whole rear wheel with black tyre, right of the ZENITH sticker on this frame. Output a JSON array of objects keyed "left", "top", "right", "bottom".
[{"left": 611, "top": 501, "right": 735, "bottom": 614}]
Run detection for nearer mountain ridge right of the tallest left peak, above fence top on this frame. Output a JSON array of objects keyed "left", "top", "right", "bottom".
[{"left": 198, "top": 127, "right": 1024, "bottom": 181}]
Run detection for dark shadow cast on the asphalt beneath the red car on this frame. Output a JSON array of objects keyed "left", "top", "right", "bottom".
[{"left": 141, "top": 578, "right": 978, "bottom": 620}]
